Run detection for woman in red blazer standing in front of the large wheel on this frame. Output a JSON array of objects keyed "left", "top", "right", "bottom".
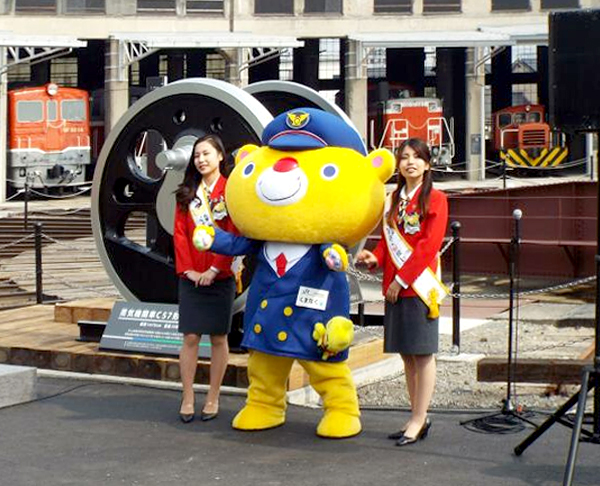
[{"left": 173, "top": 135, "right": 235, "bottom": 423}]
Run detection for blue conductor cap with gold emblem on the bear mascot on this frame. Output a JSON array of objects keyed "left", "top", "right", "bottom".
[{"left": 262, "top": 108, "right": 367, "bottom": 155}]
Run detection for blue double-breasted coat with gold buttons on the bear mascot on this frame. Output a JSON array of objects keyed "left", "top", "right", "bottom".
[{"left": 211, "top": 227, "right": 350, "bottom": 362}]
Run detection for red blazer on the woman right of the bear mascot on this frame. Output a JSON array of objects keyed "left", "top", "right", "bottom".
[{"left": 373, "top": 188, "right": 448, "bottom": 297}]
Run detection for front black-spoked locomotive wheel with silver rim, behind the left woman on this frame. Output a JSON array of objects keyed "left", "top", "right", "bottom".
[{"left": 92, "top": 78, "right": 272, "bottom": 303}]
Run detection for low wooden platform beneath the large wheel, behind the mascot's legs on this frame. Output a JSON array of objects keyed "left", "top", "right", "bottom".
[{"left": 0, "top": 298, "right": 385, "bottom": 390}]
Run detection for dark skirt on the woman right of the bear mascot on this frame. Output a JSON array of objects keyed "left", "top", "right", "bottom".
[{"left": 383, "top": 297, "right": 439, "bottom": 354}]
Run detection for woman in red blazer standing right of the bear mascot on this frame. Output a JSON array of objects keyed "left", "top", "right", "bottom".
[{"left": 357, "top": 139, "right": 448, "bottom": 446}]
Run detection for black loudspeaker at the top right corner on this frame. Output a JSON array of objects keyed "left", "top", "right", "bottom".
[{"left": 548, "top": 10, "right": 600, "bottom": 133}]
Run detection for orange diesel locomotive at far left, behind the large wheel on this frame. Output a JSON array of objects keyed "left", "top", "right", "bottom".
[{"left": 7, "top": 83, "right": 90, "bottom": 189}]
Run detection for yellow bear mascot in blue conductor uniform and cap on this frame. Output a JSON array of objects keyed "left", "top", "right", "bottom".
[{"left": 194, "top": 108, "right": 395, "bottom": 438}]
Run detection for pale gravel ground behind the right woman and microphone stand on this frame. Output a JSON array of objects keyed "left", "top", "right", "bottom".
[{"left": 358, "top": 321, "right": 594, "bottom": 410}]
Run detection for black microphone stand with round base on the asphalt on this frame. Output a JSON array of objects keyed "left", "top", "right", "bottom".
[{"left": 460, "top": 209, "right": 536, "bottom": 434}]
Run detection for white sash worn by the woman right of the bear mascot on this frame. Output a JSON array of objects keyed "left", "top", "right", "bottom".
[{"left": 383, "top": 198, "right": 450, "bottom": 318}]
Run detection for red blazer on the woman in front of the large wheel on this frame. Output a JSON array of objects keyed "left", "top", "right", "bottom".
[{"left": 173, "top": 176, "right": 236, "bottom": 279}]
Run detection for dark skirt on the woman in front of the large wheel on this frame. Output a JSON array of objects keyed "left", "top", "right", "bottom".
[{"left": 179, "top": 278, "right": 235, "bottom": 335}]
